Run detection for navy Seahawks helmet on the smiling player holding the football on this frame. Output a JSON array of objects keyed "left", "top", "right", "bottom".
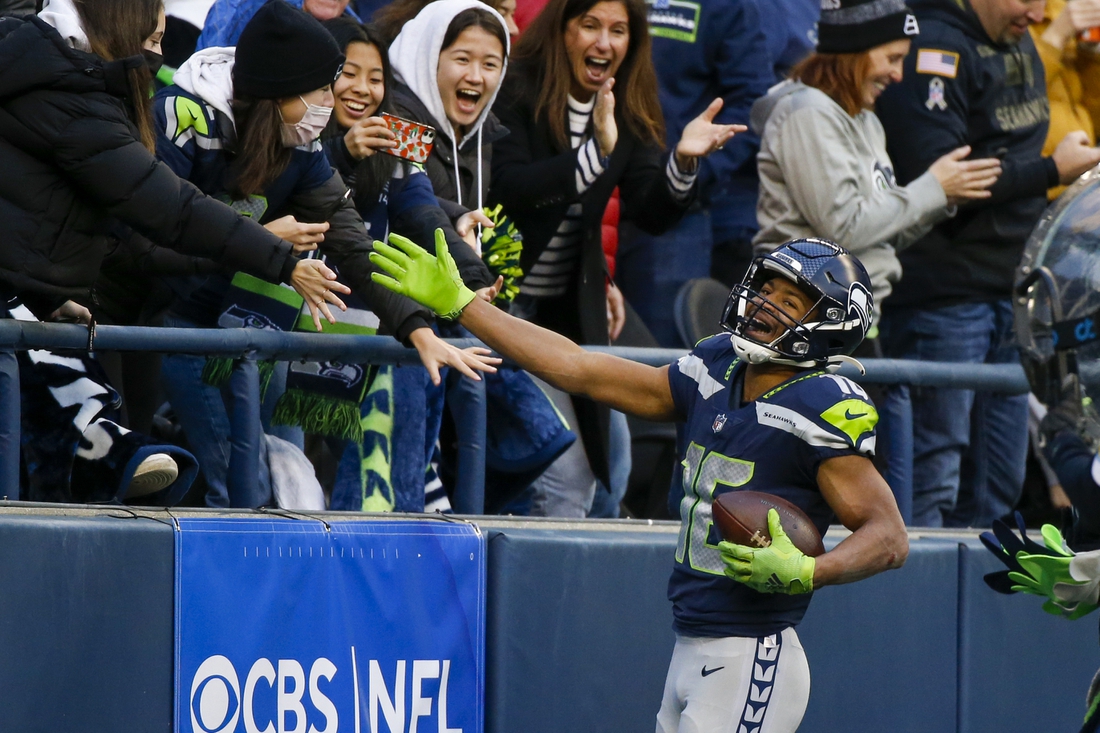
[{"left": 722, "top": 238, "right": 875, "bottom": 369}]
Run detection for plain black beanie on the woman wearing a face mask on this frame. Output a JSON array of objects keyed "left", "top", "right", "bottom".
[{"left": 233, "top": 0, "right": 344, "bottom": 99}]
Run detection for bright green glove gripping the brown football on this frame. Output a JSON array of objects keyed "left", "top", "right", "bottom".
[{"left": 718, "top": 510, "right": 816, "bottom": 595}]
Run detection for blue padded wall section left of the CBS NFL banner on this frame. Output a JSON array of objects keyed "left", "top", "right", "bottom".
[{"left": 0, "top": 516, "right": 175, "bottom": 733}]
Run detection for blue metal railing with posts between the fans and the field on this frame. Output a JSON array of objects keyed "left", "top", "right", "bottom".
[{"left": 0, "top": 320, "right": 1027, "bottom": 514}]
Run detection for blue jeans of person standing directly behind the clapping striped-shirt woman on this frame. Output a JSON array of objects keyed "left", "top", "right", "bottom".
[{"left": 615, "top": 209, "right": 718, "bottom": 349}]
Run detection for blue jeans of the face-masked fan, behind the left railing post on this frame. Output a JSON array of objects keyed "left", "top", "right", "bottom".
[{"left": 161, "top": 316, "right": 279, "bottom": 507}]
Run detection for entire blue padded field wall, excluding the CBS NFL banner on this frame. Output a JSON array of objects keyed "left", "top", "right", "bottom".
[{"left": 0, "top": 502, "right": 1100, "bottom": 733}]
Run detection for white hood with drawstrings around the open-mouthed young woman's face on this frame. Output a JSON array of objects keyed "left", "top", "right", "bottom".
[{"left": 389, "top": 0, "right": 510, "bottom": 209}]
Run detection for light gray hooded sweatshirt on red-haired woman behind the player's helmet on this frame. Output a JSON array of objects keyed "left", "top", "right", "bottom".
[{"left": 750, "top": 81, "right": 948, "bottom": 309}]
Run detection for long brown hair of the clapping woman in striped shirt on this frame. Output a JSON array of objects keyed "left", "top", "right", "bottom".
[{"left": 512, "top": 0, "right": 664, "bottom": 150}]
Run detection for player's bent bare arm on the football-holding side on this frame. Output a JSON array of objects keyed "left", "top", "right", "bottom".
[{"left": 814, "top": 456, "right": 909, "bottom": 589}]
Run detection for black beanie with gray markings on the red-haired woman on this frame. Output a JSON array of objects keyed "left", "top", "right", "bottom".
[{"left": 817, "top": 0, "right": 920, "bottom": 54}]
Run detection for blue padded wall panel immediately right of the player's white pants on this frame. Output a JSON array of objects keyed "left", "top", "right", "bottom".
[{"left": 798, "top": 540, "right": 959, "bottom": 733}]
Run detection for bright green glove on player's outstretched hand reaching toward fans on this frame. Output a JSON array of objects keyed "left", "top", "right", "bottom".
[{"left": 371, "top": 229, "right": 475, "bottom": 320}]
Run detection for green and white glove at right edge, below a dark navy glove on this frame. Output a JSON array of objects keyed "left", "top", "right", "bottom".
[{"left": 1009, "top": 524, "right": 1100, "bottom": 621}]
